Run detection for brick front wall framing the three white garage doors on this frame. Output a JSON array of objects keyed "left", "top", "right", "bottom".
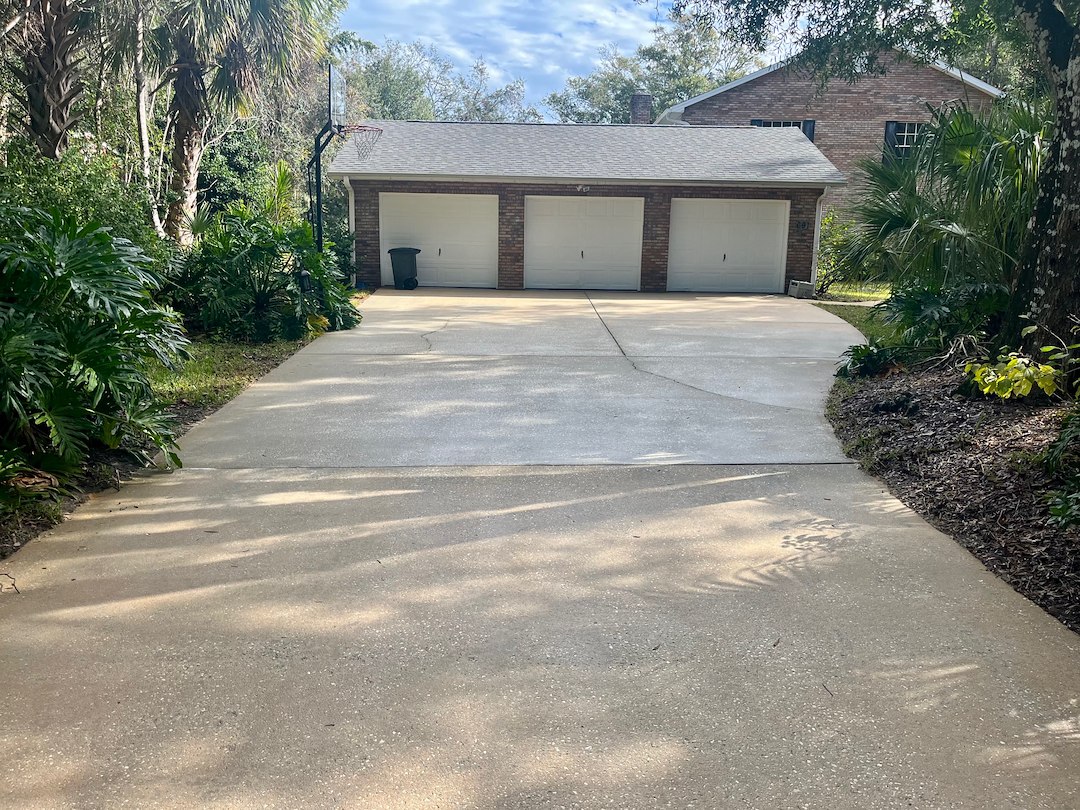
[{"left": 351, "top": 178, "right": 822, "bottom": 293}]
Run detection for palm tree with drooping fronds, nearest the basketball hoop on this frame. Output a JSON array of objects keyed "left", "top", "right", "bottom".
[{"left": 157, "top": 0, "right": 338, "bottom": 244}]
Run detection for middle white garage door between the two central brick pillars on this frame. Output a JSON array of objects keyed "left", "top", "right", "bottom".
[{"left": 525, "top": 197, "right": 645, "bottom": 289}]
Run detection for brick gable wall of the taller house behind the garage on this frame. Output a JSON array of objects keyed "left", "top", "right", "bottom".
[{"left": 683, "top": 56, "right": 993, "bottom": 205}]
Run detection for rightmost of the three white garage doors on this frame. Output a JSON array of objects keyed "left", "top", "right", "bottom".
[{"left": 667, "top": 200, "right": 789, "bottom": 293}]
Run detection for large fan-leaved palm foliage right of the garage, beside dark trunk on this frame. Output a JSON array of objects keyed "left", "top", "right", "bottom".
[{"left": 834, "top": 102, "right": 1050, "bottom": 348}]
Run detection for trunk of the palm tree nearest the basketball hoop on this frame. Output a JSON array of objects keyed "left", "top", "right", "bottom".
[{"left": 165, "top": 33, "right": 210, "bottom": 245}]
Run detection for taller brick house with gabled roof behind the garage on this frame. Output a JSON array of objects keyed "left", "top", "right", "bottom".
[{"left": 657, "top": 53, "right": 1003, "bottom": 205}]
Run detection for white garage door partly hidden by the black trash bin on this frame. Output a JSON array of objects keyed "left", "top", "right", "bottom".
[{"left": 379, "top": 192, "right": 499, "bottom": 287}]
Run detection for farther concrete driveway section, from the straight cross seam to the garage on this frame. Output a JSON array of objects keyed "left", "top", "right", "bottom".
[{"left": 184, "top": 291, "right": 861, "bottom": 469}]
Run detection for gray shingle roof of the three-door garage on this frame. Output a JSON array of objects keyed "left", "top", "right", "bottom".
[{"left": 328, "top": 121, "right": 843, "bottom": 186}]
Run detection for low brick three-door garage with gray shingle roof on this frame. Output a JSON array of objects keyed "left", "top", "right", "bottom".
[{"left": 328, "top": 121, "right": 843, "bottom": 293}]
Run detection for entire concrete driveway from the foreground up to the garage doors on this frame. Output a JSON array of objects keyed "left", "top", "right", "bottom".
[{"left": 0, "top": 292, "right": 1080, "bottom": 810}]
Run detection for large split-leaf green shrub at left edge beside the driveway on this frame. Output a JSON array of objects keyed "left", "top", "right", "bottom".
[{"left": 0, "top": 208, "right": 187, "bottom": 492}]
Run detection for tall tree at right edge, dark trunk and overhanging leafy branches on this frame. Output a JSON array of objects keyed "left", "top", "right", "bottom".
[{"left": 676, "top": 0, "right": 1080, "bottom": 341}]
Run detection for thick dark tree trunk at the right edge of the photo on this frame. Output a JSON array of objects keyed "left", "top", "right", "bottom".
[{"left": 1011, "top": 1, "right": 1080, "bottom": 351}]
